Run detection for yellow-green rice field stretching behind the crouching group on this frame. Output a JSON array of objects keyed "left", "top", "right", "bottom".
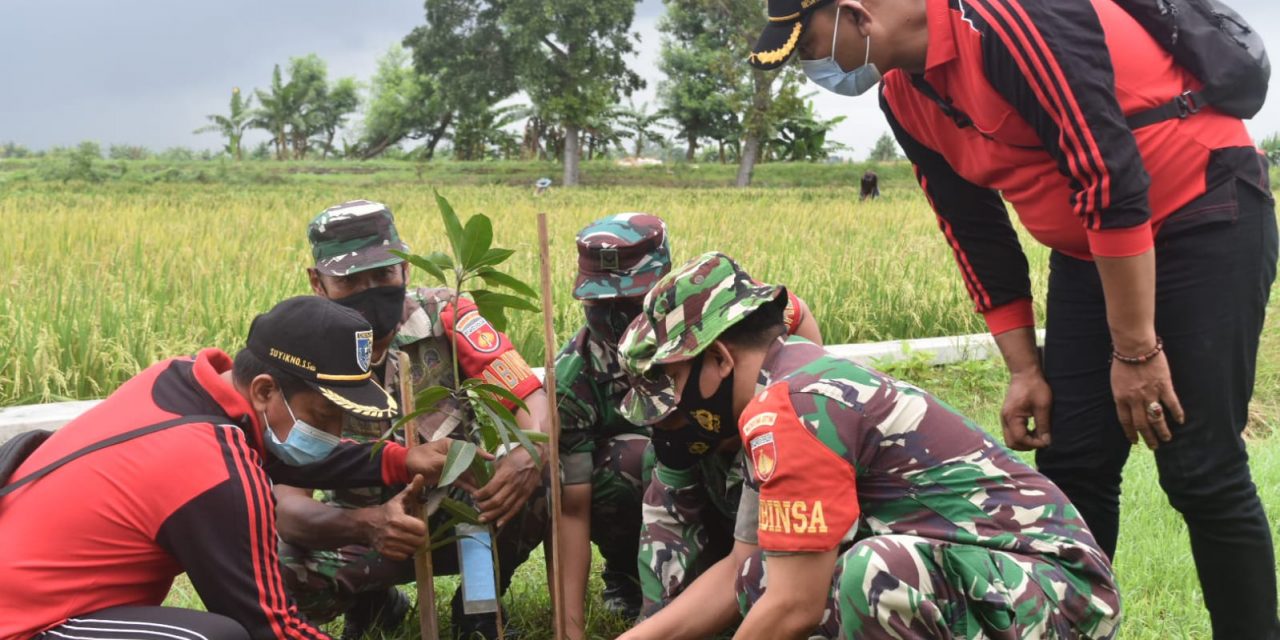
[{"left": 0, "top": 177, "right": 1029, "bottom": 406}]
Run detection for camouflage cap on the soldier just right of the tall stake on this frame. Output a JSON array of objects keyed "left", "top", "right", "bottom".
[{"left": 573, "top": 214, "right": 671, "bottom": 300}]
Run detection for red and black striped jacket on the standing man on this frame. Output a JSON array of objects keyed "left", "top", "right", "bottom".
[{"left": 881, "top": 0, "right": 1253, "bottom": 333}]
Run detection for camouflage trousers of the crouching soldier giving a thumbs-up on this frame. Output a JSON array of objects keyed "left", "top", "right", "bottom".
[{"left": 279, "top": 488, "right": 549, "bottom": 623}]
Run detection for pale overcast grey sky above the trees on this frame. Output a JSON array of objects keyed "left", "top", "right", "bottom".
[{"left": 0, "top": 0, "right": 1280, "bottom": 157}]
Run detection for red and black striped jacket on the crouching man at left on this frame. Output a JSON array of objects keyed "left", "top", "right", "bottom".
[{"left": 0, "top": 349, "right": 407, "bottom": 639}]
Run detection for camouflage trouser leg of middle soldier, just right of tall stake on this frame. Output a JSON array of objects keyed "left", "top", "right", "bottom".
[{"left": 591, "top": 434, "right": 649, "bottom": 586}]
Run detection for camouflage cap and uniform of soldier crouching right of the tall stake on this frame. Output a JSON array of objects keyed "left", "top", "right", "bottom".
[{"left": 556, "top": 214, "right": 671, "bottom": 613}]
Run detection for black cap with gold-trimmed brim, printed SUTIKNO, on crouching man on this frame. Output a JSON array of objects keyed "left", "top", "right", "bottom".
[{"left": 247, "top": 296, "right": 398, "bottom": 419}]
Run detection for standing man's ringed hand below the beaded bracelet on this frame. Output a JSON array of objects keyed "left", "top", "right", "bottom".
[{"left": 1111, "top": 352, "right": 1187, "bottom": 449}]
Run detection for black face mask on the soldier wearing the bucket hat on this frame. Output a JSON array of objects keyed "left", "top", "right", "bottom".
[{"left": 653, "top": 353, "right": 737, "bottom": 470}]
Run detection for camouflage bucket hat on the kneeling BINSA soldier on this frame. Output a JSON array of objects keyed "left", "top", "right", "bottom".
[{"left": 618, "top": 252, "right": 785, "bottom": 425}]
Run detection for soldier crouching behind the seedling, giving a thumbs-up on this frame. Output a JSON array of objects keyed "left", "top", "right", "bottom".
[{"left": 275, "top": 200, "right": 547, "bottom": 639}]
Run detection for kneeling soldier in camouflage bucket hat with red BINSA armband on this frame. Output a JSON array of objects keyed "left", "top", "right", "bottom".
[{"left": 620, "top": 253, "right": 1120, "bottom": 640}]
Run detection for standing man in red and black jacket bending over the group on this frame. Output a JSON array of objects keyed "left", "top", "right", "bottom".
[{"left": 751, "top": 0, "right": 1280, "bottom": 639}]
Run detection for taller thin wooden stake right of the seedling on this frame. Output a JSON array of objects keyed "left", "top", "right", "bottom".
[{"left": 538, "top": 214, "right": 564, "bottom": 640}]
